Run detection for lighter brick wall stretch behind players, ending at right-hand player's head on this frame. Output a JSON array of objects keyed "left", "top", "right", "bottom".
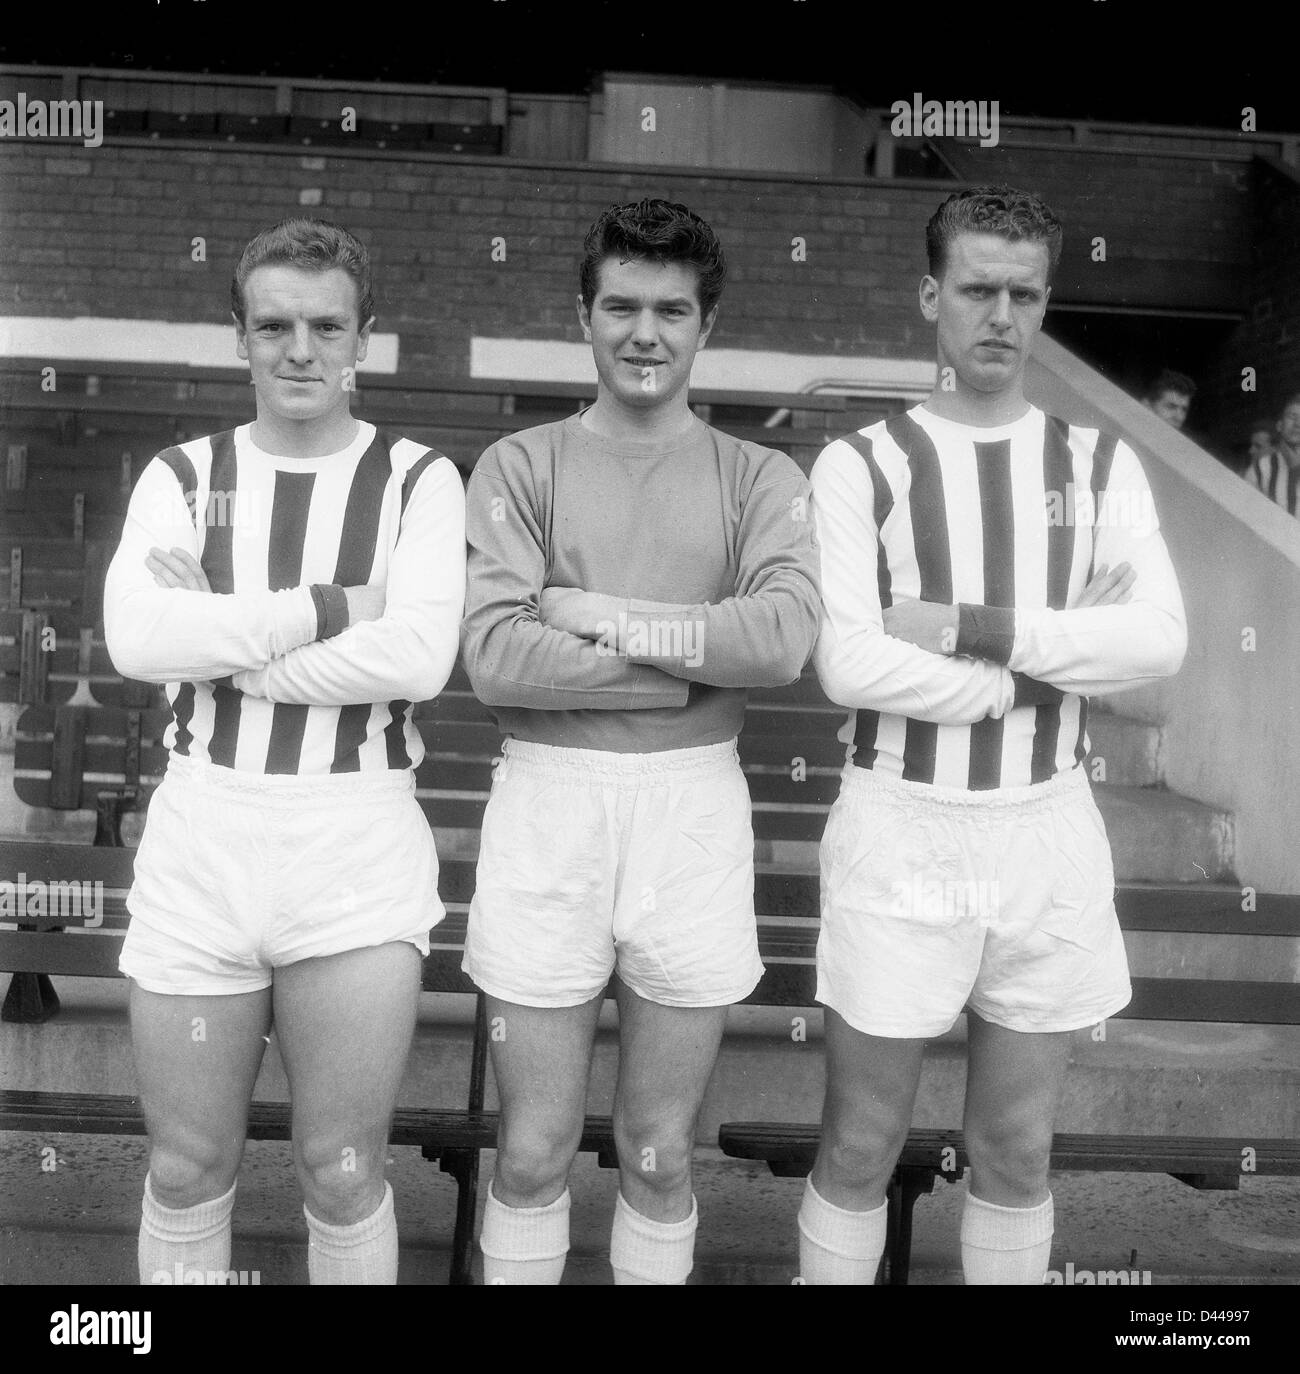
[{"left": 0, "top": 144, "right": 936, "bottom": 376}]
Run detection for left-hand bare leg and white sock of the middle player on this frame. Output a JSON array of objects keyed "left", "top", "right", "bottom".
[{"left": 480, "top": 992, "right": 605, "bottom": 1285}]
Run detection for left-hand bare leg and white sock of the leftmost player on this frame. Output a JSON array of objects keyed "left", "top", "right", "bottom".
[{"left": 131, "top": 980, "right": 271, "bottom": 1283}]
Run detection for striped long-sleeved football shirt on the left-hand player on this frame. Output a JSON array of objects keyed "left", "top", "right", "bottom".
[{"left": 104, "top": 423, "right": 464, "bottom": 775}]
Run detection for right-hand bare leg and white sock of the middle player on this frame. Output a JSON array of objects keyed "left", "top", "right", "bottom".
[{"left": 610, "top": 982, "right": 727, "bottom": 1285}]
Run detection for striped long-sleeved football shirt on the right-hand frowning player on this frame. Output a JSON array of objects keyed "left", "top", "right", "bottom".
[{"left": 812, "top": 405, "right": 1186, "bottom": 790}]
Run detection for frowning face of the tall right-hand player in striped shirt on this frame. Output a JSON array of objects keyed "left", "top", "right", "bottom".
[{"left": 921, "top": 234, "right": 1051, "bottom": 393}]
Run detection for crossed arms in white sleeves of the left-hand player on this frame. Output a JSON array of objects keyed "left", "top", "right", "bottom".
[{"left": 104, "top": 459, "right": 464, "bottom": 706}]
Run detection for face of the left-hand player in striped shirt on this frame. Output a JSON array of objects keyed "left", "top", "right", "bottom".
[{"left": 235, "top": 262, "right": 374, "bottom": 420}]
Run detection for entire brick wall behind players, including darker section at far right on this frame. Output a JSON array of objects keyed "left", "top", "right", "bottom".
[{"left": 0, "top": 143, "right": 1275, "bottom": 450}]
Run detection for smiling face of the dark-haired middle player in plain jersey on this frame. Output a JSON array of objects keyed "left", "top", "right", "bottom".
[{"left": 577, "top": 256, "right": 717, "bottom": 409}]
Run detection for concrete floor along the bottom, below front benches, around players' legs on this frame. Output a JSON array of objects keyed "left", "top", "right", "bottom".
[{"left": 0, "top": 1132, "right": 1300, "bottom": 1285}]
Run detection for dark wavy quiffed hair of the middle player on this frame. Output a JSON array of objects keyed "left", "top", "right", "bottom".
[{"left": 579, "top": 198, "right": 727, "bottom": 317}]
